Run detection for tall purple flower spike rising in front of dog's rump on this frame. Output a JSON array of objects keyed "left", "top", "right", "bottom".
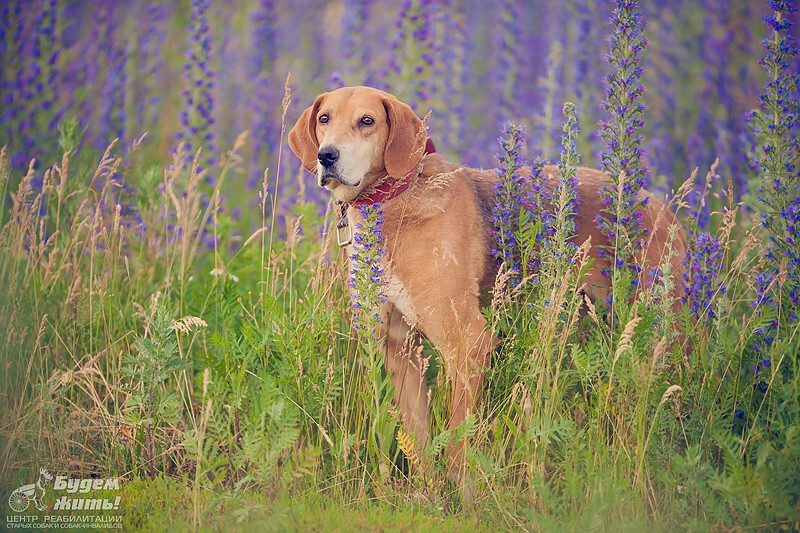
[{"left": 595, "top": 0, "right": 648, "bottom": 283}]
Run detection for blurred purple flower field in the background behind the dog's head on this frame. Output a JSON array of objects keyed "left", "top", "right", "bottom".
[{"left": 0, "top": 0, "right": 780, "bottom": 229}]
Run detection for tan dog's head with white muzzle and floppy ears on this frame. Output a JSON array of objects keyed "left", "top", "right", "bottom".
[{"left": 289, "top": 87, "right": 426, "bottom": 201}]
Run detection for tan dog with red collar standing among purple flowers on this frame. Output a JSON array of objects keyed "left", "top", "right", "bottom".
[{"left": 289, "top": 87, "right": 686, "bottom": 477}]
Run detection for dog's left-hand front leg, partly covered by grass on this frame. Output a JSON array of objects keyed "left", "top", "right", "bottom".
[{"left": 384, "top": 306, "right": 430, "bottom": 451}]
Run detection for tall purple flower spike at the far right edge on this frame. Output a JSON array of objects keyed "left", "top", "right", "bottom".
[{"left": 748, "top": 0, "right": 800, "bottom": 358}]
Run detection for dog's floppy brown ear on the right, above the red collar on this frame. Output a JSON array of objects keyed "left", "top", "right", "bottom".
[{"left": 383, "top": 96, "right": 427, "bottom": 178}]
